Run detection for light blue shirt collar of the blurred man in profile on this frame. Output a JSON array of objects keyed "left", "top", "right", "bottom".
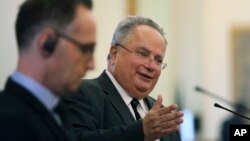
[{"left": 11, "top": 71, "right": 59, "bottom": 111}]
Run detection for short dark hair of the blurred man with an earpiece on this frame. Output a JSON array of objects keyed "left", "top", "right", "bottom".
[{"left": 15, "top": 0, "right": 92, "bottom": 49}]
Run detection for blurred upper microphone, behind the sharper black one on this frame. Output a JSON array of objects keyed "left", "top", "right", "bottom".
[{"left": 195, "top": 86, "right": 250, "bottom": 111}]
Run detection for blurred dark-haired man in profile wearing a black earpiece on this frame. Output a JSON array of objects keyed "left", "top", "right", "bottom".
[{"left": 0, "top": 0, "right": 96, "bottom": 141}]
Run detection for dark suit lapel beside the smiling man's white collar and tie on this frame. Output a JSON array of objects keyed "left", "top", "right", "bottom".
[{"left": 98, "top": 72, "right": 135, "bottom": 125}]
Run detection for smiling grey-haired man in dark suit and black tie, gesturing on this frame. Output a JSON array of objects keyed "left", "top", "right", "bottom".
[{"left": 64, "top": 17, "right": 183, "bottom": 141}]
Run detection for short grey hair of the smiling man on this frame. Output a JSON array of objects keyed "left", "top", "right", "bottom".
[{"left": 111, "top": 16, "right": 167, "bottom": 46}]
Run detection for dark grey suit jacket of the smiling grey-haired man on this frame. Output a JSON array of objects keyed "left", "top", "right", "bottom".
[{"left": 64, "top": 73, "right": 179, "bottom": 141}]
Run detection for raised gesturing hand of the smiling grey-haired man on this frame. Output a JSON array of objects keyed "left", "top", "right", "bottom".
[{"left": 143, "top": 95, "right": 183, "bottom": 141}]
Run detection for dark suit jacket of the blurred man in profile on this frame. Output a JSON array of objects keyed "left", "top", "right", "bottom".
[{"left": 0, "top": 79, "right": 71, "bottom": 141}]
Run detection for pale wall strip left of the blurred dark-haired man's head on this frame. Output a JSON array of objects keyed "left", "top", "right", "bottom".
[{"left": 0, "top": 0, "right": 22, "bottom": 89}]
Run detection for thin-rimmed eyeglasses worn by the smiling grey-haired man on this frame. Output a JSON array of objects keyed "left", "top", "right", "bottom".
[{"left": 115, "top": 43, "right": 167, "bottom": 70}]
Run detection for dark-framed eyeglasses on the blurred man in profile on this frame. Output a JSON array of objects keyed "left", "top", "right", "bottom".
[{"left": 56, "top": 31, "right": 95, "bottom": 54}]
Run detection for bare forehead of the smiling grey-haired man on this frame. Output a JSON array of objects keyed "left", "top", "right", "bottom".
[{"left": 126, "top": 25, "right": 166, "bottom": 55}]
